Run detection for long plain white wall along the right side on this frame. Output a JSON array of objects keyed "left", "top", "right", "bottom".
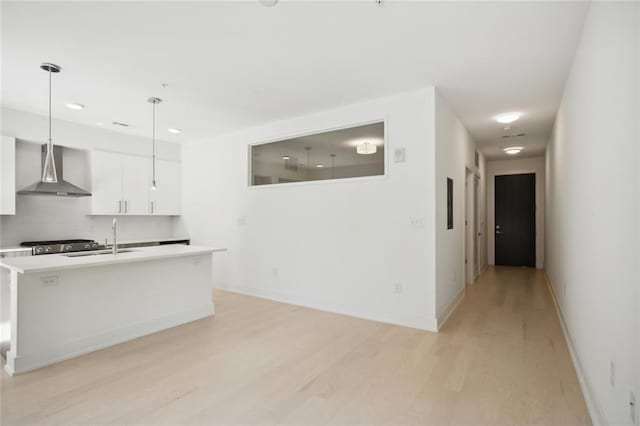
[{"left": 545, "top": 2, "right": 640, "bottom": 425}]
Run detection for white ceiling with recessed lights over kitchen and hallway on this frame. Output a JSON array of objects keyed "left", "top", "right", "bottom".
[{"left": 1, "top": 0, "right": 588, "bottom": 158}]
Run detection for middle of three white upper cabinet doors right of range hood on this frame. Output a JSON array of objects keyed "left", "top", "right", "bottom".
[{"left": 122, "top": 155, "right": 151, "bottom": 215}]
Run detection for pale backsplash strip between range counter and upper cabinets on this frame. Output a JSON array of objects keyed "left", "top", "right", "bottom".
[{"left": 0, "top": 195, "right": 173, "bottom": 246}]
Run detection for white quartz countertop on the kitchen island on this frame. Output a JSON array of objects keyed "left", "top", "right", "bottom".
[{"left": 0, "top": 244, "right": 227, "bottom": 274}]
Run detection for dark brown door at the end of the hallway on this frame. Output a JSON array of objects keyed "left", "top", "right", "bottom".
[{"left": 495, "top": 173, "right": 536, "bottom": 267}]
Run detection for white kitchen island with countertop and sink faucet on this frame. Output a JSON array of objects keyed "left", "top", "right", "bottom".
[{"left": 0, "top": 245, "right": 224, "bottom": 374}]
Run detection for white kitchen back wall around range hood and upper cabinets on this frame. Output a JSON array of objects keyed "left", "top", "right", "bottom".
[{"left": 0, "top": 108, "right": 180, "bottom": 246}]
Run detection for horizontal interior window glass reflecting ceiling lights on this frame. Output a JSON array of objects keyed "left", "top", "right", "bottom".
[{"left": 251, "top": 122, "right": 385, "bottom": 185}]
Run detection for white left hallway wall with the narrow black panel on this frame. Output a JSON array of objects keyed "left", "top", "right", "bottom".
[{"left": 432, "top": 91, "right": 485, "bottom": 320}]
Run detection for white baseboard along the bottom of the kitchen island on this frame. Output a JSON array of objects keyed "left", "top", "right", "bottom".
[{"left": 4, "top": 303, "right": 215, "bottom": 375}]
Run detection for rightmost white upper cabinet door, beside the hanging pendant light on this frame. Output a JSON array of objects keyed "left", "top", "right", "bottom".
[{"left": 149, "top": 160, "right": 180, "bottom": 215}]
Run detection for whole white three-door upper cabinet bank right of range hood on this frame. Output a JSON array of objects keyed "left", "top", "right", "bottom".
[{"left": 91, "top": 151, "right": 180, "bottom": 216}]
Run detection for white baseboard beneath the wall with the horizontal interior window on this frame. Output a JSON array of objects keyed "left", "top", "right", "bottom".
[{"left": 224, "top": 286, "right": 438, "bottom": 333}]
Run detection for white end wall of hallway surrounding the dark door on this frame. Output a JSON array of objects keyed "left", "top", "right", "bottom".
[{"left": 487, "top": 157, "right": 545, "bottom": 268}]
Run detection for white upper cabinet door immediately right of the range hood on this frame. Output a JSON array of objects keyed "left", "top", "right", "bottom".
[{"left": 91, "top": 151, "right": 123, "bottom": 215}]
